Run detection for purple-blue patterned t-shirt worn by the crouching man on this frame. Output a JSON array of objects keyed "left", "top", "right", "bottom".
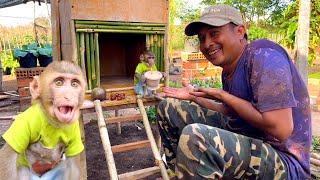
[{"left": 222, "top": 40, "right": 311, "bottom": 179}]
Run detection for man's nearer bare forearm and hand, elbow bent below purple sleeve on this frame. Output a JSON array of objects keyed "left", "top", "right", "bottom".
[{"left": 191, "top": 88, "right": 293, "bottom": 141}]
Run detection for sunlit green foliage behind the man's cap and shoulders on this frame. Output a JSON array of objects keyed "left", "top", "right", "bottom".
[{"left": 169, "top": 0, "right": 320, "bottom": 65}]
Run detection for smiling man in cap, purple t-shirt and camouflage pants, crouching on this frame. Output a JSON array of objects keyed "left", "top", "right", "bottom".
[{"left": 157, "top": 5, "right": 311, "bottom": 179}]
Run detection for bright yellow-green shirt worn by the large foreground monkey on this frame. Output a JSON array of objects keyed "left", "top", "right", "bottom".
[{"left": 3, "top": 103, "right": 84, "bottom": 166}]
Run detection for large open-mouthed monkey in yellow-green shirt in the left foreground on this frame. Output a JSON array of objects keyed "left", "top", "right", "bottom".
[{"left": 0, "top": 61, "right": 86, "bottom": 180}]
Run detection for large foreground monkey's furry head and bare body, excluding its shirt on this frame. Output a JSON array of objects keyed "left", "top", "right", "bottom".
[{"left": 0, "top": 61, "right": 86, "bottom": 179}]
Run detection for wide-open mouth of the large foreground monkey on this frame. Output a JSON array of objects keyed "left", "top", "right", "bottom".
[{"left": 54, "top": 105, "right": 75, "bottom": 123}]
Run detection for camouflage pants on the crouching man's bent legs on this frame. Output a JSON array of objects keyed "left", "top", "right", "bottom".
[{"left": 157, "top": 98, "right": 287, "bottom": 180}]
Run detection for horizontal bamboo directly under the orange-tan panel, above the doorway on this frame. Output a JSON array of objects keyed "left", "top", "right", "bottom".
[{"left": 76, "top": 24, "right": 166, "bottom": 31}]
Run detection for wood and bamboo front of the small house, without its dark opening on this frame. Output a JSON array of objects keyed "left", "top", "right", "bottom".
[{"left": 51, "top": 0, "right": 169, "bottom": 89}]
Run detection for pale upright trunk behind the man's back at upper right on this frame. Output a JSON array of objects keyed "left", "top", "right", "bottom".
[{"left": 295, "top": 0, "right": 311, "bottom": 84}]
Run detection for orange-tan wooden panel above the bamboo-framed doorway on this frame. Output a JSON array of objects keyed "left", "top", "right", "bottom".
[{"left": 70, "top": 0, "right": 168, "bottom": 23}]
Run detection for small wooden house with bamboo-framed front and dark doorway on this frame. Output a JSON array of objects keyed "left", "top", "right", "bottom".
[{"left": 51, "top": 0, "right": 169, "bottom": 89}]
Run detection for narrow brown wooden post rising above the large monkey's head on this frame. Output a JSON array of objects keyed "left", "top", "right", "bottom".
[{"left": 51, "top": 0, "right": 61, "bottom": 61}]
